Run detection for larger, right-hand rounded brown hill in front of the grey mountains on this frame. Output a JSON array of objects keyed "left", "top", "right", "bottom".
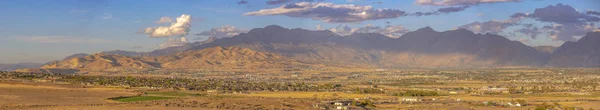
[{"left": 148, "top": 46, "right": 308, "bottom": 69}]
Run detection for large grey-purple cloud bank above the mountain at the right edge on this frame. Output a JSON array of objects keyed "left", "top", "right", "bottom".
[{"left": 459, "top": 3, "right": 600, "bottom": 41}]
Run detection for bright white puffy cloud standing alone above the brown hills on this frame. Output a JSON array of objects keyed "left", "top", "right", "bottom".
[{"left": 144, "top": 14, "right": 192, "bottom": 38}]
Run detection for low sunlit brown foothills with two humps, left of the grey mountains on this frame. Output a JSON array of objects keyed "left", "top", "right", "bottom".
[{"left": 38, "top": 46, "right": 319, "bottom": 71}]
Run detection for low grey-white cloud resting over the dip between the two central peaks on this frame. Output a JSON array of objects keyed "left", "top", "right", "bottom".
[{"left": 329, "top": 24, "right": 410, "bottom": 38}]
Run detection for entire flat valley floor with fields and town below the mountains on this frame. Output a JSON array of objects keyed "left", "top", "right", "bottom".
[{"left": 0, "top": 69, "right": 600, "bottom": 110}]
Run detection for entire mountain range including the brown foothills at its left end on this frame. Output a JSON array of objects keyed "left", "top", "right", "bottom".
[{"left": 29, "top": 25, "right": 600, "bottom": 70}]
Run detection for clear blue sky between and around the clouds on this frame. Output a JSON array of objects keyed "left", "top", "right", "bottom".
[{"left": 0, "top": 0, "right": 600, "bottom": 63}]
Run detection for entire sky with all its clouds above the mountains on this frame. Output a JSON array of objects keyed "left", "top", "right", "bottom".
[{"left": 0, "top": 0, "right": 600, "bottom": 63}]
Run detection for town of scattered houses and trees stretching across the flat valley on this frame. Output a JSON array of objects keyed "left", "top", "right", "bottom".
[{"left": 0, "top": 68, "right": 600, "bottom": 109}]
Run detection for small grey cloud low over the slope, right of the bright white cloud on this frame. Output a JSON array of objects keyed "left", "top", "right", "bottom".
[{"left": 196, "top": 25, "right": 248, "bottom": 39}]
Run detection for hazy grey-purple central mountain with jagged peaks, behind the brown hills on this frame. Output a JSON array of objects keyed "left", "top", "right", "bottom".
[{"left": 192, "top": 25, "right": 544, "bottom": 68}]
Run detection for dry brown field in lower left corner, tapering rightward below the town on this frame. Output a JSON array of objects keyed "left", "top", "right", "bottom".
[{"left": 0, "top": 82, "right": 316, "bottom": 110}]
